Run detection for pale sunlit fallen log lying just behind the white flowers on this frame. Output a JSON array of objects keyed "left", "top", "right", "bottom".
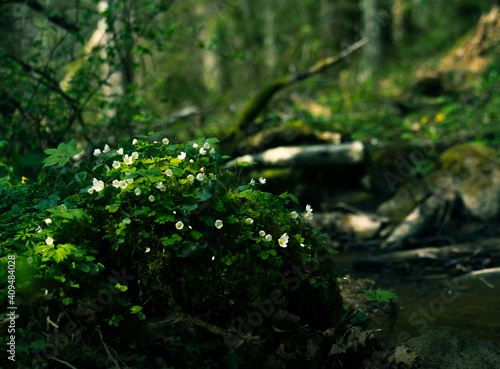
[{"left": 228, "top": 141, "right": 365, "bottom": 167}]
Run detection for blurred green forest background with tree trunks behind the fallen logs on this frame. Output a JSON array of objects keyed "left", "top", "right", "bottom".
[{"left": 0, "top": 0, "right": 500, "bottom": 178}]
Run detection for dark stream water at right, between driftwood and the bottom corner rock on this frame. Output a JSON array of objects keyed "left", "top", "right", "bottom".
[{"left": 335, "top": 252, "right": 500, "bottom": 346}]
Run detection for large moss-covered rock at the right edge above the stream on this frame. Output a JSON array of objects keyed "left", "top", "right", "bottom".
[{"left": 433, "top": 143, "right": 500, "bottom": 220}]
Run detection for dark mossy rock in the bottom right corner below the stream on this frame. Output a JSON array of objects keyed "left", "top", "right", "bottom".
[{"left": 409, "top": 326, "right": 500, "bottom": 369}]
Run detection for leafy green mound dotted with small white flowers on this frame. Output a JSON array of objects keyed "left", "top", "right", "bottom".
[{"left": 0, "top": 132, "right": 341, "bottom": 365}]
